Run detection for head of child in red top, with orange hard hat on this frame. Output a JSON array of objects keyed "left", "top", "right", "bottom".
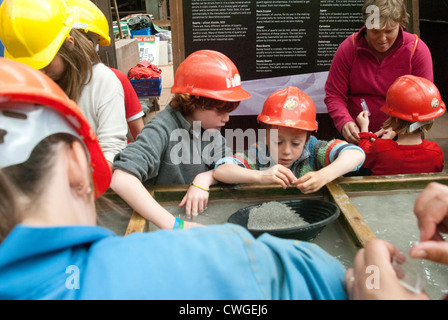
[{"left": 381, "top": 75, "right": 446, "bottom": 134}]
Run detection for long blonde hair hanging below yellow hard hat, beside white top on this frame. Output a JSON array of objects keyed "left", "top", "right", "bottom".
[{"left": 57, "top": 29, "right": 101, "bottom": 101}]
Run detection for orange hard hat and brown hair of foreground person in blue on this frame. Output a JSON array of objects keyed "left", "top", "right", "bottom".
[{"left": 0, "top": 58, "right": 111, "bottom": 241}]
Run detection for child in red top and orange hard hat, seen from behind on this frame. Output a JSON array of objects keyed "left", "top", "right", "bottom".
[{"left": 356, "top": 75, "right": 446, "bottom": 175}]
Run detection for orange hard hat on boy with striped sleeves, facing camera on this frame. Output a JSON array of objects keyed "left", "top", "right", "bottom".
[{"left": 258, "top": 87, "right": 317, "bottom": 131}]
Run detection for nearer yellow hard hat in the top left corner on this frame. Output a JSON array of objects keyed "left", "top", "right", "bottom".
[{"left": 0, "top": 0, "right": 74, "bottom": 69}]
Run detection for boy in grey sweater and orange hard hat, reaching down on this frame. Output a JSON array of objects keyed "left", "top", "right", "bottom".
[{"left": 111, "top": 50, "right": 251, "bottom": 229}]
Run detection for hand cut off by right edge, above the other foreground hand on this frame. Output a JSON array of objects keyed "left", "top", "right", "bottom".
[{"left": 410, "top": 182, "right": 448, "bottom": 265}]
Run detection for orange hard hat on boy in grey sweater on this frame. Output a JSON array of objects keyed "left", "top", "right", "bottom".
[{"left": 171, "top": 50, "right": 251, "bottom": 102}]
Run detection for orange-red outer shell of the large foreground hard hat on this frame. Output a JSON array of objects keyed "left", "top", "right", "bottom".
[{"left": 0, "top": 58, "right": 112, "bottom": 198}]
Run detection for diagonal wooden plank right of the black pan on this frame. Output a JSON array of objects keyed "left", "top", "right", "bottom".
[{"left": 326, "top": 182, "right": 375, "bottom": 247}]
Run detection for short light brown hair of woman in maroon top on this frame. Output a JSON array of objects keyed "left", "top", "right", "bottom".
[{"left": 362, "top": 0, "right": 409, "bottom": 29}]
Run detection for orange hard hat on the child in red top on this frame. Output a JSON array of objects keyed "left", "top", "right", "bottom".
[{"left": 381, "top": 75, "right": 446, "bottom": 122}]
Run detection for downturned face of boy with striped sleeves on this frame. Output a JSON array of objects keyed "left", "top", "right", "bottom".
[{"left": 266, "top": 126, "right": 308, "bottom": 167}]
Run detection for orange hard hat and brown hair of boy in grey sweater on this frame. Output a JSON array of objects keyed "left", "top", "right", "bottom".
[{"left": 170, "top": 50, "right": 251, "bottom": 115}]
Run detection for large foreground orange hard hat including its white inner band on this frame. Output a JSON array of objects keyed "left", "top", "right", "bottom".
[{"left": 0, "top": 58, "right": 112, "bottom": 198}]
